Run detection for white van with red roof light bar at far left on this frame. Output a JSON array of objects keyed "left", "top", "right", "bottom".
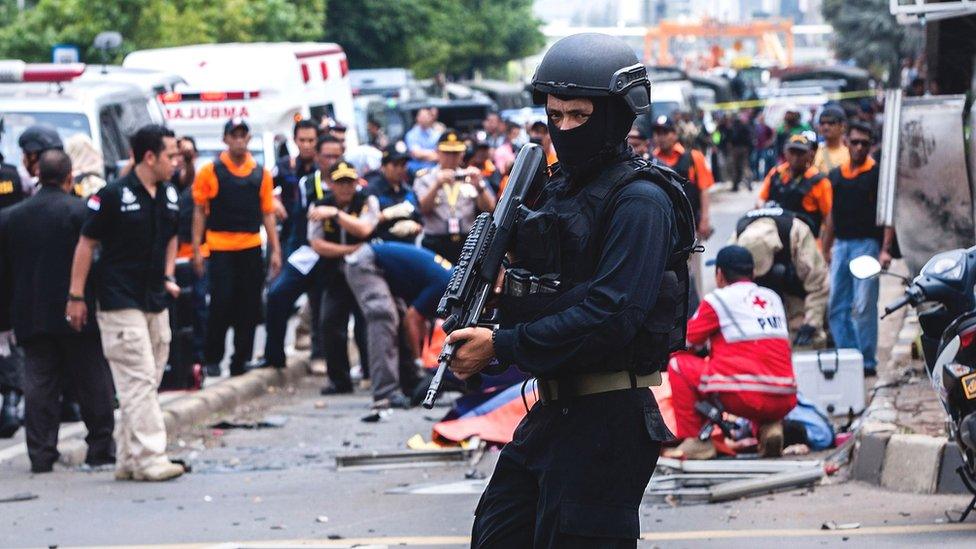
[{"left": 0, "top": 61, "right": 161, "bottom": 176}]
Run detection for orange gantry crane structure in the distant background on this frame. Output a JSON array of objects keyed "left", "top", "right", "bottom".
[{"left": 644, "top": 19, "right": 794, "bottom": 67}]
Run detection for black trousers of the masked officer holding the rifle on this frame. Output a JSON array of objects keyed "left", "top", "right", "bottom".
[{"left": 471, "top": 389, "right": 671, "bottom": 549}]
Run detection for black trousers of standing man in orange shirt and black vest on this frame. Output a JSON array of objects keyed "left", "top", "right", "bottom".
[{"left": 204, "top": 247, "right": 265, "bottom": 375}]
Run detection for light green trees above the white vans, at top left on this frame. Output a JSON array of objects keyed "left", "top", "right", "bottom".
[{"left": 0, "top": 0, "right": 325, "bottom": 62}]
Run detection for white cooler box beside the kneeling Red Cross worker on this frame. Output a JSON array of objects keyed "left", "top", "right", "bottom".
[{"left": 793, "top": 349, "right": 864, "bottom": 416}]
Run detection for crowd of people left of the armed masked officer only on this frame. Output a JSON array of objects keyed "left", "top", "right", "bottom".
[{"left": 0, "top": 109, "right": 528, "bottom": 480}]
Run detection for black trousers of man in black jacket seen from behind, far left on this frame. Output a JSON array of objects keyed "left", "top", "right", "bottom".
[{"left": 21, "top": 332, "right": 115, "bottom": 467}]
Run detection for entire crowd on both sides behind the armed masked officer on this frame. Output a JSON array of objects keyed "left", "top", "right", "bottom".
[{"left": 0, "top": 86, "right": 894, "bottom": 480}]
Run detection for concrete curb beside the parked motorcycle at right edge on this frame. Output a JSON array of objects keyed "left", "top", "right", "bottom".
[{"left": 851, "top": 313, "right": 969, "bottom": 494}]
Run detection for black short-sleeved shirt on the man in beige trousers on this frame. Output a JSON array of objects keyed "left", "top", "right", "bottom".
[{"left": 82, "top": 172, "right": 179, "bottom": 313}]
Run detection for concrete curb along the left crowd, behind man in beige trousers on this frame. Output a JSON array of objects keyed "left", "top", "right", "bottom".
[{"left": 58, "top": 352, "right": 308, "bottom": 466}]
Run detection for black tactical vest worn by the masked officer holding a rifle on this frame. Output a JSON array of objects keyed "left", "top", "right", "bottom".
[{"left": 508, "top": 156, "right": 696, "bottom": 375}]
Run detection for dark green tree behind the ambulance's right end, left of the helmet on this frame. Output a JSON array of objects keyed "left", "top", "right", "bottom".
[{"left": 326, "top": 0, "right": 545, "bottom": 77}]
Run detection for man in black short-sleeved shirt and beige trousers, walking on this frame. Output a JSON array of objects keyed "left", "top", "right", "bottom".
[{"left": 66, "top": 124, "right": 184, "bottom": 481}]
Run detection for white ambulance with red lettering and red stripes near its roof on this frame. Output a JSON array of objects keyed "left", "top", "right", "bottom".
[{"left": 123, "top": 43, "right": 356, "bottom": 168}]
